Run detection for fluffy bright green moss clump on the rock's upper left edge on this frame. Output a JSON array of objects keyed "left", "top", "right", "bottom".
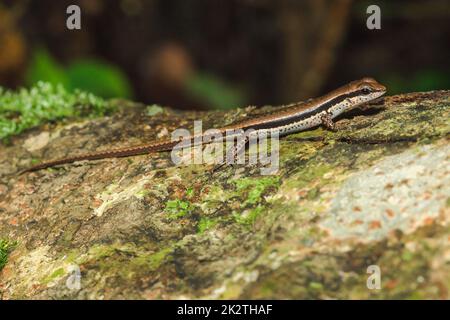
[{"left": 0, "top": 82, "right": 115, "bottom": 139}]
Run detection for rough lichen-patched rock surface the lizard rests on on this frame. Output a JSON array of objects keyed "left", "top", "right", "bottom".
[{"left": 0, "top": 91, "right": 450, "bottom": 299}]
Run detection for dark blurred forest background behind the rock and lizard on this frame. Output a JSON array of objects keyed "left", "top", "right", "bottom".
[{"left": 0, "top": 0, "right": 450, "bottom": 109}]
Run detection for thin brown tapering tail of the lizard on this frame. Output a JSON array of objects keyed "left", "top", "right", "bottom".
[{"left": 19, "top": 141, "right": 179, "bottom": 175}]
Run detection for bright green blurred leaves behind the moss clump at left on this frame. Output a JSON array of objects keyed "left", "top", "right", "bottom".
[{"left": 26, "top": 47, "right": 132, "bottom": 98}]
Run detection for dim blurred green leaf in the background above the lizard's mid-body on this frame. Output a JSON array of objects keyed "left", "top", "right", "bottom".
[{"left": 186, "top": 73, "right": 245, "bottom": 110}]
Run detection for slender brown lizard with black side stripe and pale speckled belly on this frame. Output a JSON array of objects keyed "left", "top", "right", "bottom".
[{"left": 20, "top": 77, "right": 386, "bottom": 174}]
